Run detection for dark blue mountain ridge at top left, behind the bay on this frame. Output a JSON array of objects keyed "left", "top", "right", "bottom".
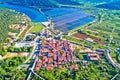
[{"left": 0, "top": 0, "right": 57, "bottom": 8}]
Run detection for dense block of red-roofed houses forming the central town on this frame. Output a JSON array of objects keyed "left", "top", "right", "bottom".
[{"left": 35, "top": 39, "right": 78, "bottom": 70}]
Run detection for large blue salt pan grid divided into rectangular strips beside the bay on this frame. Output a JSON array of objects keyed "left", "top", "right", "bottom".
[{"left": 45, "top": 8, "right": 95, "bottom": 32}]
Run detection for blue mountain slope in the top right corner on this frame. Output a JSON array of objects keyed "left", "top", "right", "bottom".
[{"left": 96, "top": 0, "right": 120, "bottom": 10}]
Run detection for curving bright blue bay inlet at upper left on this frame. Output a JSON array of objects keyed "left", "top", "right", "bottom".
[{"left": 0, "top": 3, "right": 48, "bottom": 23}]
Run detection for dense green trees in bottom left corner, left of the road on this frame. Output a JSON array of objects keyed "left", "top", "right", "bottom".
[{"left": 0, "top": 57, "right": 27, "bottom": 80}]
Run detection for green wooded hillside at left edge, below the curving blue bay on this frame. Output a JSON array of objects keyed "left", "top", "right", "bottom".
[{"left": 0, "top": 7, "right": 21, "bottom": 43}]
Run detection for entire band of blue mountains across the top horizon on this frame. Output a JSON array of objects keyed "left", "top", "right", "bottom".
[{"left": 0, "top": 0, "right": 120, "bottom": 10}]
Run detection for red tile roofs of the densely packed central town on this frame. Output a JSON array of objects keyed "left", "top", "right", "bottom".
[{"left": 34, "top": 39, "right": 78, "bottom": 70}]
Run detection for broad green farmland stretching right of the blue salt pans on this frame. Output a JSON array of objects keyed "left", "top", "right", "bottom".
[{"left": 67, "top": 3, "right": 120, "bottom": 64}]
